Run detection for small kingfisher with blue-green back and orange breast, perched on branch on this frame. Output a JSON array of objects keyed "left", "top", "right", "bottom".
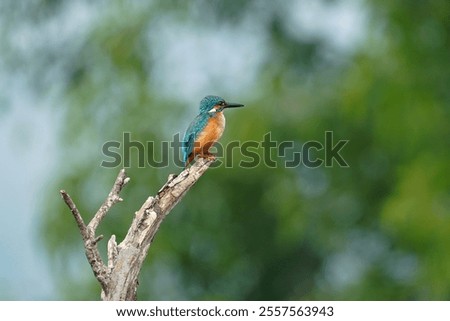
[{"left": 183, "top": 96, "right": 244, "bottom": 167}]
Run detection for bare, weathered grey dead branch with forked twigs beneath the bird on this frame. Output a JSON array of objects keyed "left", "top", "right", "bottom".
[{"left": 60, "top": 158, "right": 213, "bottom": 300}]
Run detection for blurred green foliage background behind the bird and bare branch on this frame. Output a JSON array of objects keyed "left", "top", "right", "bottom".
[{"left": 1, "top": 0, "right": 450, "bottom": 300}]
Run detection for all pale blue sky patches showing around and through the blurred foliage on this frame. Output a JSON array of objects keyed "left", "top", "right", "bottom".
[{"left": 0, "top": 0, "right": 366, "bottom": 300}]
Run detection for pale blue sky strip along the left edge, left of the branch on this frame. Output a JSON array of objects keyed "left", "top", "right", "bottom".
[{"left": 0, "top": 101, "right": 58, "bottom": 300}]
